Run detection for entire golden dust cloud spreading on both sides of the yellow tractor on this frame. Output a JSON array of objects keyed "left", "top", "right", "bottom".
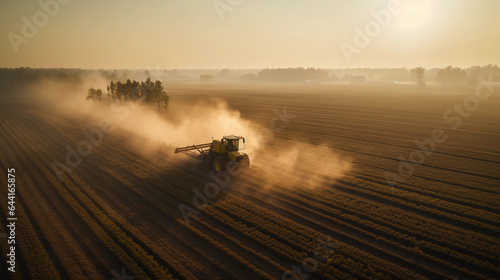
[{"left": 27, "top": 77, "right": 351, "bottom": 188}]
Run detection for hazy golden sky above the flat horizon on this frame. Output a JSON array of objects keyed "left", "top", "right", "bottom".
[{"left": 0, "top": 0, "right": 500, "bottom": 69}]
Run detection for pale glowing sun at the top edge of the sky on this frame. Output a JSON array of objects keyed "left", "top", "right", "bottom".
[{"left": 397, "top": 0, "right": 432, "bottom": 29}]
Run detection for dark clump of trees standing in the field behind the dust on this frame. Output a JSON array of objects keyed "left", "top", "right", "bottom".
[{"left": 86, "top": 77, "right": 170, "bottom": 113}]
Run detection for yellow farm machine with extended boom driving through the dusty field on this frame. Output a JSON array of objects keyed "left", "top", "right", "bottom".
[{"left": 174, "top": 135, "right": 250, "bottom": 172}]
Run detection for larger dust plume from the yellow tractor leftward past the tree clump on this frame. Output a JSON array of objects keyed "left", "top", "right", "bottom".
[{"left": 30, "top": 80, "right": 264, "bottom": 158}]
